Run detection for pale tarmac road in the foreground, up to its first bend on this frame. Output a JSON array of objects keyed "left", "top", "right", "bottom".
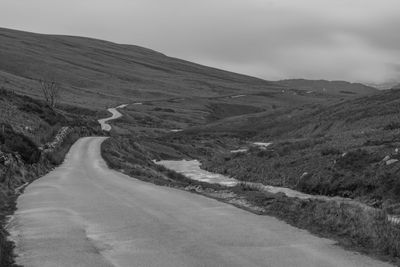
[{"left": 8, "top": 107, "right": 390, "bottom": 267}]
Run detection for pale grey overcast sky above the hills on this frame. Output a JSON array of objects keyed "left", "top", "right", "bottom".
[{"left": 0, "top": 0, "right": 400, "bottom": 82}]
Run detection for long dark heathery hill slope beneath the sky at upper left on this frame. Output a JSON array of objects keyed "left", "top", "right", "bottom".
[{"left": 0, "top": 28, "right": 279, "bottom": 108}]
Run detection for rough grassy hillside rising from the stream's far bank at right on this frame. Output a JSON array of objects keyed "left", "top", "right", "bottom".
[{"left": 163, "top": 90, "right": 400, "bottom": 208}]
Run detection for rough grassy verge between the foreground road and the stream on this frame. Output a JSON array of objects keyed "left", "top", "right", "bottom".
[{"left": 102, "top": 137, "right": 400, "bottom": 264}]
